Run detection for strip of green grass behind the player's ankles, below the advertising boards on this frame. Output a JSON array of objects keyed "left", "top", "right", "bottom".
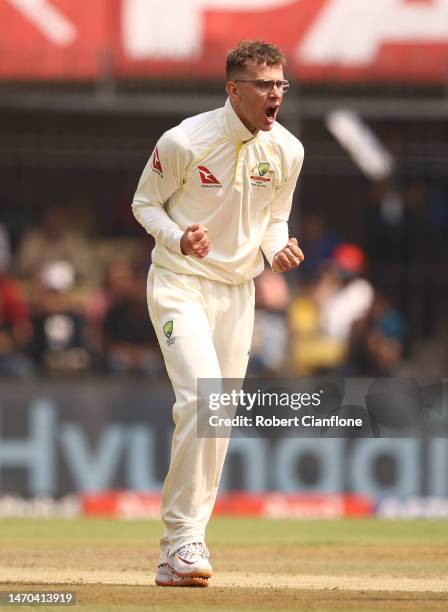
[{"left": 0, "top": 518, "right": 448, "bottom": 546}]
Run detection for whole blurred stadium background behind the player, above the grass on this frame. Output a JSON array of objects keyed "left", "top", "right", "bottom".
[{"left": 0, "top": 0, "right": 448, "bottom": 517}]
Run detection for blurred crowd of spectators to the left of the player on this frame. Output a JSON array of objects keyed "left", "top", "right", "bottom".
[{"left": 0, "top": 206, "right": 162, "bottom": 379}]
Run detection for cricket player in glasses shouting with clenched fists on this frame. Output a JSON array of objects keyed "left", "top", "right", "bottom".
[{"left": 132, "top": 41, "right": 304, "bottom": 586}]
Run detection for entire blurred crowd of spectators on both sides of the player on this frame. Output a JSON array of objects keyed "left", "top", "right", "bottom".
[{"left": 0, "top": 196, "right": 420, "bottom": 379}]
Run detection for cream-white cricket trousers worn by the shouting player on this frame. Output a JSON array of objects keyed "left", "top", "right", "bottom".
[{"left": 147, "top": 264, "right": 255, "bottom": 563}]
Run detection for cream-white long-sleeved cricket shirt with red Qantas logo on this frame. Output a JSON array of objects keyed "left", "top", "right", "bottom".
[{"left": 132, "top": 99, "right": 304, "bottom": 284}]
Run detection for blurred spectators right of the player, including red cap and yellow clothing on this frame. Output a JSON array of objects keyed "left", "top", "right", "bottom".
[{"left": 250, "top": 213, "right": 407, "bottom": 377}]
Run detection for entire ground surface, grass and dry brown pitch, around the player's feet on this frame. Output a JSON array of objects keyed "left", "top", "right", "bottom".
[{"left": 0, "top": 519, "right": 448, "bottom": 612}]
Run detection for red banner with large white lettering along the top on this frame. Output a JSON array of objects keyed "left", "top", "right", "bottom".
[{"left": 0, "top": 0, "right": 448, "bottom": 83}]
